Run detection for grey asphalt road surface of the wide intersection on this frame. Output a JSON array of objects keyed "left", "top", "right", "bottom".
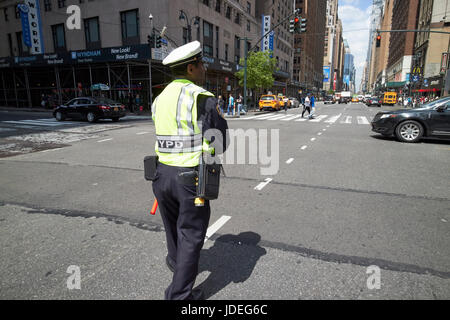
[{"left": 0, "top": 104, "right": 450, "bottom": 300}]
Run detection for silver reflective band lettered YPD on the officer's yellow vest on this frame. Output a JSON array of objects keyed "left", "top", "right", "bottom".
[{"left": 156, "top": 134, "right": 203, "bottom": 153}]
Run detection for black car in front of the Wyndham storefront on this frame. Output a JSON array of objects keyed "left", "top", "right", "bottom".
[{"left": 53, "top": 97, "right": 126, "bottom": 123}]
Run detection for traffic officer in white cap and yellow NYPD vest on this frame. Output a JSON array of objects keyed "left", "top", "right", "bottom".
[{"left": 152, "top": 41, "right": 228, "bottom": 300}]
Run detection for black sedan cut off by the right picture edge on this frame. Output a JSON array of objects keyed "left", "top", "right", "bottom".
[{"left": 372, "top": 97, "right": 450, "bottom": 143}]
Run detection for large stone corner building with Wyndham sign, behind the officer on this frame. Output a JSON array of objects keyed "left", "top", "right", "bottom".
[{"left": 0, "top": 0, "right": 258, "bottom": 108}]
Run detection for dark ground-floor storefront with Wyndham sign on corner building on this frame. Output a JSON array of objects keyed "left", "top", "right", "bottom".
[{"left": 0, "top": 45, "right": 171, "bottom": 108}]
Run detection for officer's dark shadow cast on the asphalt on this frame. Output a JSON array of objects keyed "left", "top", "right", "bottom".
[{"left": 197, "top": 232, "right": 266, "bottom": 299}]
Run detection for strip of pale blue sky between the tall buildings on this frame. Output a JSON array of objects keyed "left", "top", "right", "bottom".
[{"left": 338, "top": 0, "right": 372, "bottom": 90}]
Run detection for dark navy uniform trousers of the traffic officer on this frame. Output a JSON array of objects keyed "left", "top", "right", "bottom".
[{"left": 153, "top": 163, "right": 211, "bottom": 300}]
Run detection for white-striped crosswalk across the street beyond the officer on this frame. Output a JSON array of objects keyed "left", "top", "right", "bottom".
[{"left": 229, "top": 113, "right": 370, "bottom": 125}]
